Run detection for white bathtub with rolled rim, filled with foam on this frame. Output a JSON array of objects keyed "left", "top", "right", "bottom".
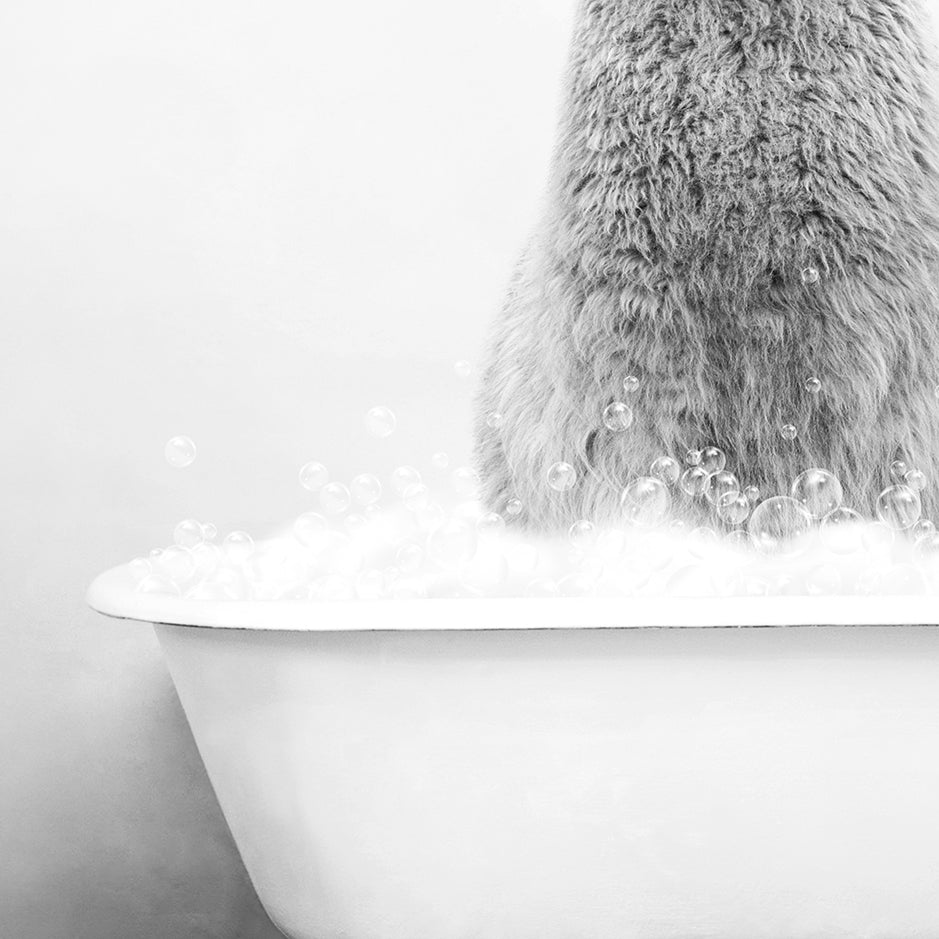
[{"left": 89, "top": 568, "right": 939, "bottom": 939}]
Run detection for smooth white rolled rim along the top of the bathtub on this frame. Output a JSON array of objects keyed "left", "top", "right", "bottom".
[{"left": 86, "top": 564, "right": 939, "bottom": 632}]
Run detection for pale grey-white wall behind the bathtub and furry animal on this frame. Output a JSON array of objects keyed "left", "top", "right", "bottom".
[{"left": 0, "top": 0, "right": 571, "bottom": 939}]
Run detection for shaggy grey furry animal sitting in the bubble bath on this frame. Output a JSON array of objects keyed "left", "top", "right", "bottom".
[{"left": 475, "top": 0, "right": 939, "bottom": 530}]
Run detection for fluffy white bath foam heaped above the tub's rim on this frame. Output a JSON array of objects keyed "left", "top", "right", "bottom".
[{"left": 128, "top": 501, "right": 939, "bottom": 601}]
